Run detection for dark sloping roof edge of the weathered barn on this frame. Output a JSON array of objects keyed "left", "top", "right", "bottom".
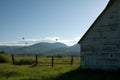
[{"left": 78, "top": 0, "right": 117, "bottom": 44}]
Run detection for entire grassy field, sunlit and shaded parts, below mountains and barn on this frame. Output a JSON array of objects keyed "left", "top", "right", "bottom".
[{"left": 0, "top": 56, "right": 120, "bottom": 80}]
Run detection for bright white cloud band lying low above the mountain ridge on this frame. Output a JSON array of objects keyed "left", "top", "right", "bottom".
[{"left": 0, "top": 37, "right": 80, "bottom": 46}]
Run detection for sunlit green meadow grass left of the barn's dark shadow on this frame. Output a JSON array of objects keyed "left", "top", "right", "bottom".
[{"left": 0, "top": 56, "right": 80, "bottom": 80}]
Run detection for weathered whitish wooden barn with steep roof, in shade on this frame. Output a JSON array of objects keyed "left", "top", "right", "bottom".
[{"left": 78, "top": 0, "right": 120, "bottom": 69}]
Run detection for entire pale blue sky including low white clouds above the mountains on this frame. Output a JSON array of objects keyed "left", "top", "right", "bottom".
[{"left": 0, "top": 0, "right": 109, "bottom": 45}]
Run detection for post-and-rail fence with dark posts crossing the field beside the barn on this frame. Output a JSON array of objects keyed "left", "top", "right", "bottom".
[{"left": 11, "top": 55, "right": 80, "bottom": 67}]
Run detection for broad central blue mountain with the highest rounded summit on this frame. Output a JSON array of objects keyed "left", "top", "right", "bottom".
[{"left": 9, "top": 42, "right": 68, "bottom": 55}]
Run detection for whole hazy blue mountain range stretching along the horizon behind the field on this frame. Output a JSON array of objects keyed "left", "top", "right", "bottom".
[{"left": 0, "top": 42, "right": 80, "bottom": 56}]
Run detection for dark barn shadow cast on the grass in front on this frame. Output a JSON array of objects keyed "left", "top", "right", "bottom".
[{"left": 54, "top": 68, "right": 120, "bottom": 80}]
